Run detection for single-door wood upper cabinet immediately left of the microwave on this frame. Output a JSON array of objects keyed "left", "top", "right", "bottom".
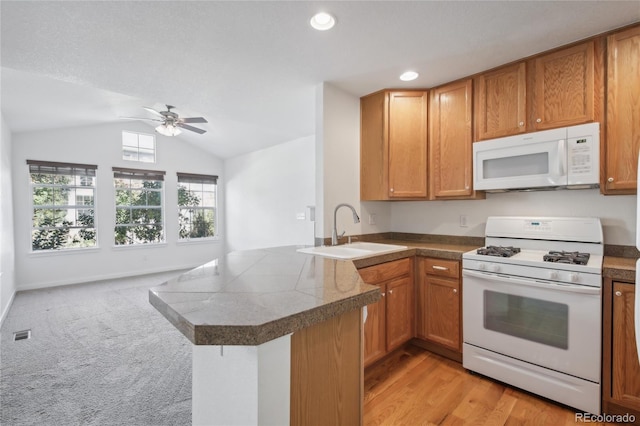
[{"left": 429, "top": 79, "right": 474, "bottom": 200}]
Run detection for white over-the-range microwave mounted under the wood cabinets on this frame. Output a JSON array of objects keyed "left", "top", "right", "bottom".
[{"left": 473, "top": 123, "right": 600, "bottom": 192}]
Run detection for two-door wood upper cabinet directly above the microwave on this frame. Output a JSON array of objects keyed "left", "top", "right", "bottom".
[{"left": 474, "top": 40, "right": 602, "bottom": 140}]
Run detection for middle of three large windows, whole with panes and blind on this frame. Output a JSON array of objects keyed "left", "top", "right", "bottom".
[{"left": 113, "top": 167, "right": 165, "bottom": 245}]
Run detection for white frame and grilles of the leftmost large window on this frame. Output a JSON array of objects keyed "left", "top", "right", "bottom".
[{"left": 26, "top": 160, "right": 100, "bottom": 255}]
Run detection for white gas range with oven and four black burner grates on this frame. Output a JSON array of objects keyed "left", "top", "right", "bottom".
[{"left": 462, "top": 217, "right": 604, "bottom": 414}]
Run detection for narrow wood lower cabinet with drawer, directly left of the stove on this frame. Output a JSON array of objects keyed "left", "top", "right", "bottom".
[{"left": 416, "top": 257, "right": 462, "bottom": 361}]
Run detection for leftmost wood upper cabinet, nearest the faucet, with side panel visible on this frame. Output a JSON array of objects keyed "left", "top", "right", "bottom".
[{"left": 360, "top": 90, "right": 428, "bottom": 200}]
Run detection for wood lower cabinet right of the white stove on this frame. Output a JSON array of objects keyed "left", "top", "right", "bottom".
[{"left": 602, "top": 278, "right": 640, "bottom": 419}]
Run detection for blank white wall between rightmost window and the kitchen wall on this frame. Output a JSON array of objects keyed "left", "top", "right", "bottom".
[{"left": 225, "top": 136, "right": 315, "bottom": 250}]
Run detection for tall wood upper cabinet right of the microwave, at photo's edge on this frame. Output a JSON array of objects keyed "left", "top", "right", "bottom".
[{"left": 600, "top": 27, "right": 640, "bottom": 194}]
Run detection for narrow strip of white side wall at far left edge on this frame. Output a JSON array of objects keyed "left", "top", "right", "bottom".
[{"left": 0, "top": 115, "right": 16, "bottom": 324}]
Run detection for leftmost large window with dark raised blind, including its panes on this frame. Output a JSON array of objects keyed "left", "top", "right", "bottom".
[{"left": 27, "top": 160, "right": 98, "bottom": 251}]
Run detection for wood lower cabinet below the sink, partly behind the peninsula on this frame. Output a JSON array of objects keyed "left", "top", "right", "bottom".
[{"left": 359, "top": 258, "right": 414, "bottom": 367}]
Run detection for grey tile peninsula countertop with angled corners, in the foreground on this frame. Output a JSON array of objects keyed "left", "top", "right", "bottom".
[{"left": 149, "top": 246, "right": 381, "bottom": 346}]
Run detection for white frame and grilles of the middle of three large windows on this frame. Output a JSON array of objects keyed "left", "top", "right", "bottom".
[{"left": 112, "top": 167, "right": 167, "bottom": 248}]
